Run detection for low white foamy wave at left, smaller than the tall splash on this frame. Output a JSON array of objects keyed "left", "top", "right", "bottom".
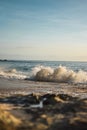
[{"left": 0, "top": 69, "right": 26, "bottom": 79}]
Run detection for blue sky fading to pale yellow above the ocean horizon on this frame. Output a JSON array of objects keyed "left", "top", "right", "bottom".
[{"left": 0, "top": 0, "right": 87, "bottom": 61}]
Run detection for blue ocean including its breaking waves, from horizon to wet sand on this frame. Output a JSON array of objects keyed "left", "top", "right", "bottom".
[{"left": 0, "top": 60, "right": 87, "bottom": 84}]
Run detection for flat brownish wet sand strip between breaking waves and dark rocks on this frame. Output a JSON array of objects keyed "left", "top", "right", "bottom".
[{"left": 0, "top": 78, "right": 87, "bottom": 98}]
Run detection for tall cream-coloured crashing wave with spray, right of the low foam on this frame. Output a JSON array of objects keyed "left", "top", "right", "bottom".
[{"left": 33, "top": 65, "right": 87, "bottom": 83}]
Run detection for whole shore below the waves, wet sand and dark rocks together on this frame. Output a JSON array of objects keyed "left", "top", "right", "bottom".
[{"left": 0, "top": 78, "right": 87, "bottom": 130}]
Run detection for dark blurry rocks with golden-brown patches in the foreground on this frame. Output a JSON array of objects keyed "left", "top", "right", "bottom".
[{"left": 0, "top": 94, "right": 87, "bottom": 130}]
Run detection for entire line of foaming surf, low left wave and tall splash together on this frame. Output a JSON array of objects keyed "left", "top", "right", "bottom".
[{"left": 0, "top": 65, "right": 87, "bottom": 83}]
